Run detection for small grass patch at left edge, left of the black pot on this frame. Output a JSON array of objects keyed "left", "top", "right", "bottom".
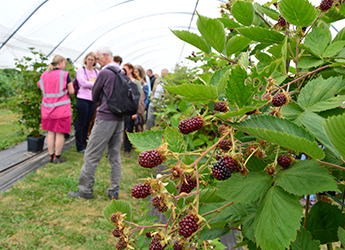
[{"left": 0, "top": 108, "right": 27, "bottom": 150}]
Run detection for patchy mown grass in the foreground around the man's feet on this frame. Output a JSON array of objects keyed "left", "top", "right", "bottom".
[{"left": 0, "top": 148, "right": 154, "bottom": 250}]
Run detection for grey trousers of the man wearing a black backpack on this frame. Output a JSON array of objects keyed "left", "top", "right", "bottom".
[{"left": 79, "top": 119, "right": 123, "bottom": 194}]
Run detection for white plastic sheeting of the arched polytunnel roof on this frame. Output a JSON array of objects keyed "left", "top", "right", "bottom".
[{"left": 0, "top": 0, "right": 226, "bottom": 73}]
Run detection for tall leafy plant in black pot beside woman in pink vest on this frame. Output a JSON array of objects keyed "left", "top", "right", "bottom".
[{"left": 10, "top": 48, "right": 48, "bottom": 152}]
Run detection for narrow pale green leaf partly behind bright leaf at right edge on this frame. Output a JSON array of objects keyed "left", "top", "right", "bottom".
[{"left": 299, "top": 110, "right": 340, "bottom": 157}]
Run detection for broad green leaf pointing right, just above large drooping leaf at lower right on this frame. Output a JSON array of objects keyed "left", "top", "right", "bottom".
[{"left": 276, "top": 160, "right": 338, "bottom": 195}]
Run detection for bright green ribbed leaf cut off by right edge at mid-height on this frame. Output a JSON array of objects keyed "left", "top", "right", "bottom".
[{"left": 323, "top": 114, "right": 345, "bottom": 159}]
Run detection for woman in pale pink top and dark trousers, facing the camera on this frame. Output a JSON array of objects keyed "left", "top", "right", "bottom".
[{"left": 75, "top": 52, "right": 99, "bottom": 153}]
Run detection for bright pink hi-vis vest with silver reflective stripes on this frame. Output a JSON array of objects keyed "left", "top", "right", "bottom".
[{"left": 37, "top": 70, "right": 72, "bottom": 119}]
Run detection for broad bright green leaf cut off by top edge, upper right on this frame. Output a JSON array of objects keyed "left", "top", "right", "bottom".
[{"left": 278, "top": 0, "right": 318, "bottom": 28}]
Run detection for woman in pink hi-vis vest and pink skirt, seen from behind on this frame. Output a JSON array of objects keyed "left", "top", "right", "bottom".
[{"left": 37, "top": 55, "right": 74, "bottom": 163}]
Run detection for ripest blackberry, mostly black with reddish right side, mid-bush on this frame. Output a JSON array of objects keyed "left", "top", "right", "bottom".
[{"left": 212, "top": 155, "right": 237, "bottom": 181}]
